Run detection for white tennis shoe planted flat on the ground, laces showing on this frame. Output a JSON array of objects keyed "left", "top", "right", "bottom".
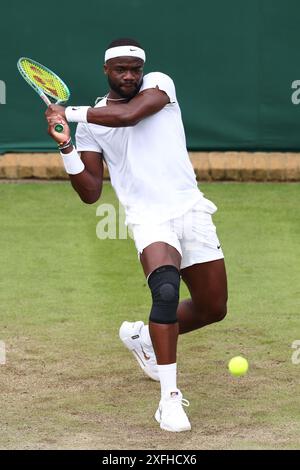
[{"left": 155, "top": 390, "right": 191, "bottom": 432}]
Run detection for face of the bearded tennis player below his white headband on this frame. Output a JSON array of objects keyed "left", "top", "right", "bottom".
[{"left": 104, "top": 57, "right": 144, "bottom": 99}]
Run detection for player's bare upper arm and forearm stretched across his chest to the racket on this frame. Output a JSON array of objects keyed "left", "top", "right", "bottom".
[{"left": 46, "top": 87, "right": 170, "bottom": 127}]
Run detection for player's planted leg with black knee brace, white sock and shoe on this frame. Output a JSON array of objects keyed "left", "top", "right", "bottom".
[{"left": 120, "top": 242, "right": 191, "bottom": 432}]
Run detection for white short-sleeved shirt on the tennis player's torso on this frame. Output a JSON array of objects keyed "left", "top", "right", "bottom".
[{"left": 76, "top": 72, "right": 207, "bottom": 224}]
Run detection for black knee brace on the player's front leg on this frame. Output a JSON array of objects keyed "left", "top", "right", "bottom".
[{"left": 148, "top": 265, "right": 180, "bottom": 323}]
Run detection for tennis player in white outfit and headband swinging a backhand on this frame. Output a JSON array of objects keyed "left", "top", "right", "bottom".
[{"left": 46, "top": 38, "right": 227, "bottom": 432}]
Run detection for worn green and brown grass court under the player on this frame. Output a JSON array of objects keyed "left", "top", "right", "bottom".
[{"left": 0, "top": 182, "right": 300, "bottom": 450}]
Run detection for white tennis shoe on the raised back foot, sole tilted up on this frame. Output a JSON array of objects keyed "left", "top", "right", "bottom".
[{"left": 119, "top": 321, "right": 159, "bottom": 382}]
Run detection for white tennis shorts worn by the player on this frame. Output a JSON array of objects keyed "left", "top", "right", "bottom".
[{"left": 130, "top": 198, "right": 224, "bottom": 269}]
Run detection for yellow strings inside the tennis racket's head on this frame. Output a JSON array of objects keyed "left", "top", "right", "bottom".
[{"left": 21, "top": 59, "right": 69, "bottom": 101}]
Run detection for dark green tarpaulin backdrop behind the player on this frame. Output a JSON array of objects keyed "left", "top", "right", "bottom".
[{"left": 0, "top": 0, "right": 300, "bottom": 153}]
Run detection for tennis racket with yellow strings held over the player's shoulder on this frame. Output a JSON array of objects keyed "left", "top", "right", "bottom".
[{"left": 17, "top": 57, "right": 70, "bottom": 132}]
